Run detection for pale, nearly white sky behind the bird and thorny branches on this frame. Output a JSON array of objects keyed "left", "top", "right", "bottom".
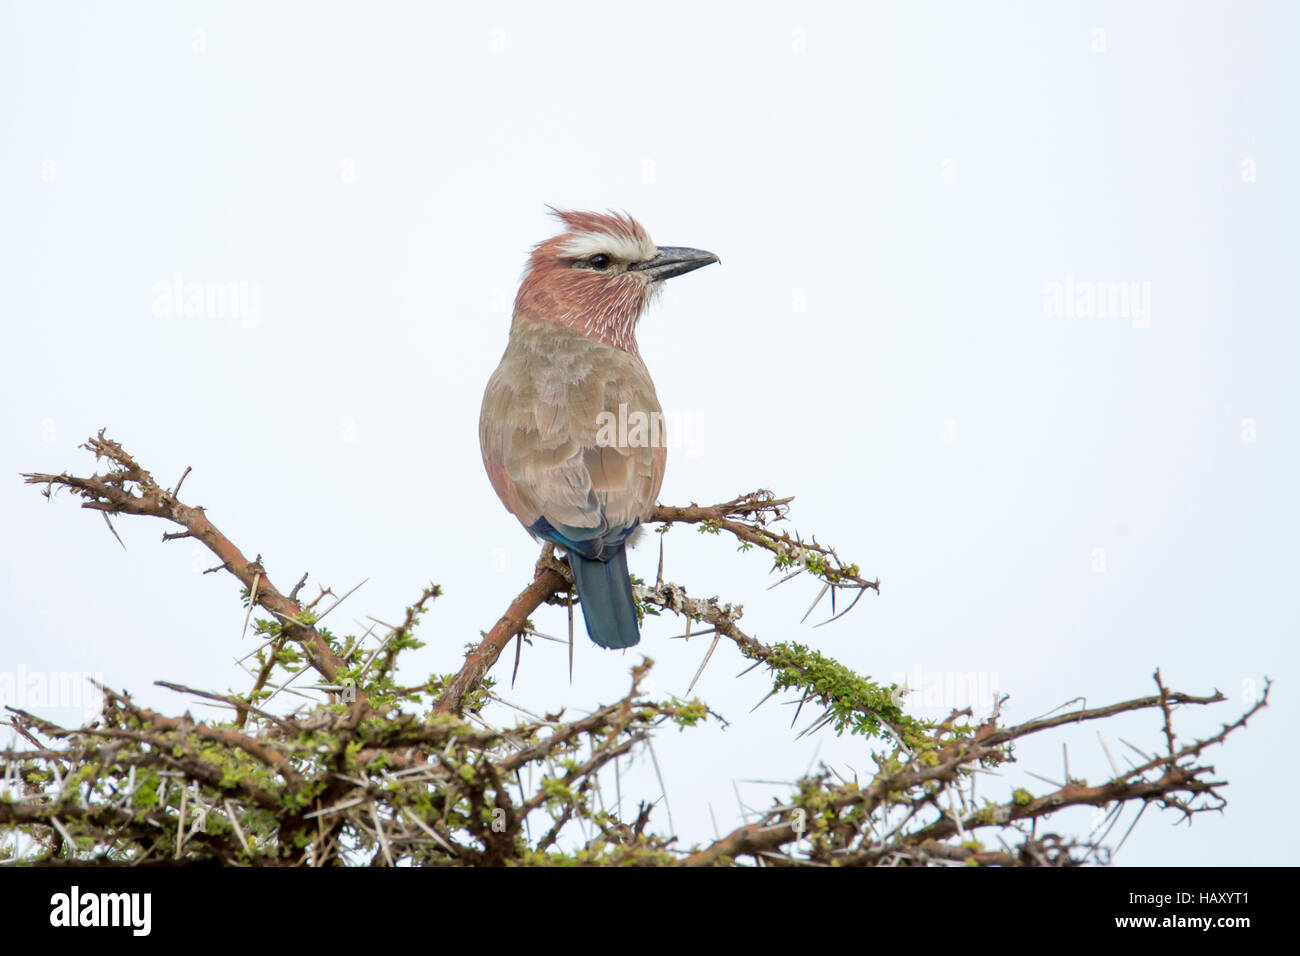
[{"left": 0, "top": 0, "right": 1300, "bottom": 865}]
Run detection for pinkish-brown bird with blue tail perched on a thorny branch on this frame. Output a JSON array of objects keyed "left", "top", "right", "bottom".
[{"left": 478, "top": 207, "right": 720, "bottom": 648}]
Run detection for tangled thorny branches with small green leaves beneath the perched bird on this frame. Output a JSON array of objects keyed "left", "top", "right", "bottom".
[{"left": 0, "top": 432, "right": 1270, "bottom": 866}]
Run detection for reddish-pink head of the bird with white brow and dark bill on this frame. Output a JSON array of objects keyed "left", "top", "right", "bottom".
[{"left": 515, "top": 208, "right": 719, "bottom": 354}]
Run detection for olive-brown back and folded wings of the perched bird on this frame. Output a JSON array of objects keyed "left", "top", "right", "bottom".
[{"left": 478, "top": 323, "right": 666, "bottom": 542}]
